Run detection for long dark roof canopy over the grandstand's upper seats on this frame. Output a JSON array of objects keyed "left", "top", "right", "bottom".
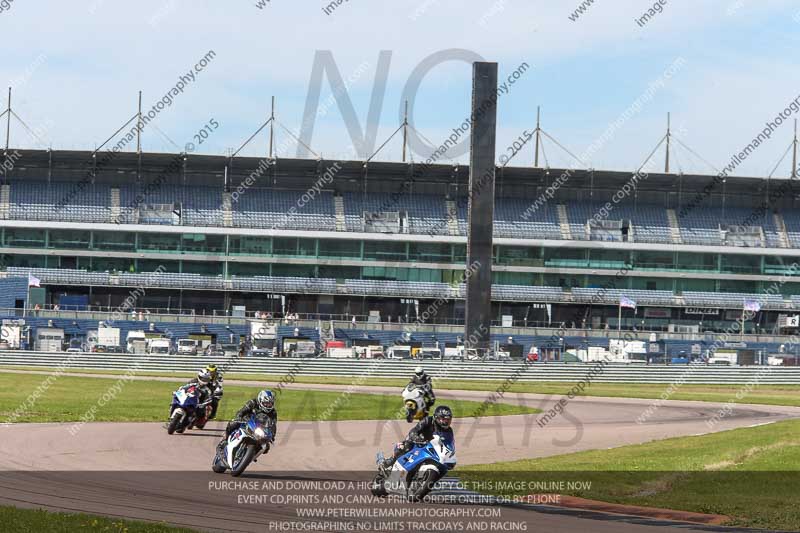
[{"left": 4, "top": 149, "right": 794, "bottom": 202}]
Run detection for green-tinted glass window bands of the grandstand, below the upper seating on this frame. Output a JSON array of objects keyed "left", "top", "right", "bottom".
[{"left": 0, "top": 228, "right": 800, "bottom": 295}]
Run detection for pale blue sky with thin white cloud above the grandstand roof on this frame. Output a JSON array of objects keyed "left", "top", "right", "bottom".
[{"left": 0, "top": 0, "right": 800, "bottom": 176}]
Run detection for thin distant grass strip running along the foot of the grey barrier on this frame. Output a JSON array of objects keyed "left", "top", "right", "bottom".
[{"left": 6, "top": 361, "right": 800, "bottom": 407}]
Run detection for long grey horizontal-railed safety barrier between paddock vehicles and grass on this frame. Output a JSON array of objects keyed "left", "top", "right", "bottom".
[{"left": 0, "top": 351, "right": 800, "bottom": 384}]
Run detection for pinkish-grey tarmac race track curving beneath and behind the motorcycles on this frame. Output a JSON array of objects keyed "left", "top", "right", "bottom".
[{"left": 0, "top": 376, "right": 800, "bottom": 533}]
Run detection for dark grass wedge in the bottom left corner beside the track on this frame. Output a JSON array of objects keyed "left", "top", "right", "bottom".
[{"left": 0, "top": 507, "right": 194, "bottom": 533}]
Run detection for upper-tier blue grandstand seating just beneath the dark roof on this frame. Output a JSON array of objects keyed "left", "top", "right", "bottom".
[{"left": 8, "top": 180, "right": 800, "bottom": 247}]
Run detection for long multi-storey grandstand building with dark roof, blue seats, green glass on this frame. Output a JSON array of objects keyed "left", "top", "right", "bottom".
[{"left": 0, "top": 150, "right": 800, "bottom": 332}]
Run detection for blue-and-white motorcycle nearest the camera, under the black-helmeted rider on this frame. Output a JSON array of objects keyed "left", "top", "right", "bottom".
[{"left": 371, "top": 432, "right": 456, "bottom": 502}]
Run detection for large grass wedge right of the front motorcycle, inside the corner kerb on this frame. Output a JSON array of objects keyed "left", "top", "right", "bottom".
[{"left": 458, "top": 420, "right": 800, "bottom": 530}]
